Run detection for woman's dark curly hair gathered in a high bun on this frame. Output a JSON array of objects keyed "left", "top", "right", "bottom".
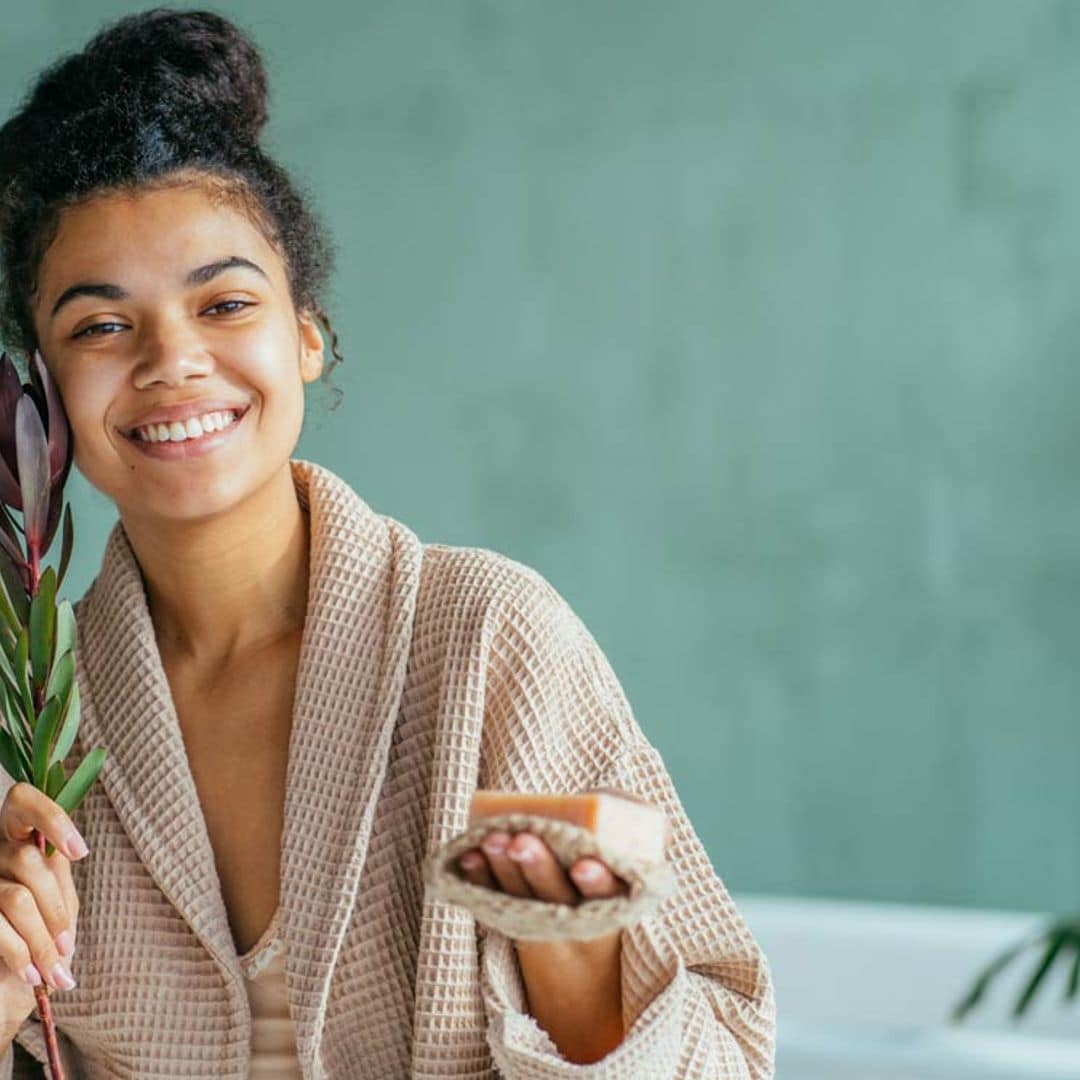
[{"left": 0, "top": 8, "right": 342, "bottom": 408}]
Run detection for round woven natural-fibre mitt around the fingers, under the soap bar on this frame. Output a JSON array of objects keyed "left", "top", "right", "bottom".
[{"left": 423, "top": 813, "right": 675, "bottom": 941}]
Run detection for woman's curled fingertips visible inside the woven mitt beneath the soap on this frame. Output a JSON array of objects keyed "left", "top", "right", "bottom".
[{"left": 458, "top": 831, "right": 630, "bottom": 905}]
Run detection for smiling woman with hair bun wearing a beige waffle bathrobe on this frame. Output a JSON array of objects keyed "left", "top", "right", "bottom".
[{"left": 0, "top": 9, "right": 773, "bottom": 1080}]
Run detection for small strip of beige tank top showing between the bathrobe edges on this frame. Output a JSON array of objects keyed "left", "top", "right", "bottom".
[{"left": 240, "top": 905, "right": 302, "bottom": 1080}]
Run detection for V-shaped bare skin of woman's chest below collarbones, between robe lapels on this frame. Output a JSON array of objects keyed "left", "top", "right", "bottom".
[{"left": 157, "top": 648, "right": 299, "bottom": 954}]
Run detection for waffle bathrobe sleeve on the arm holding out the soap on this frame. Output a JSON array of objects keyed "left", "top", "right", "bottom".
[{"left": 477, "top": 563, "right": 775, "bottom": 1080}]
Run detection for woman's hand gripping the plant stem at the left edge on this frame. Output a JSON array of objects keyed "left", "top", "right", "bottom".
[{"left": 0, "top": 781, "right": 86, "bottom": 1034}]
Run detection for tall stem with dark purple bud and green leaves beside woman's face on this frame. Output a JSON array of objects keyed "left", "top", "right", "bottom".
[{"left": 0, "top": 351, "right": 105, "bottom": 1080}]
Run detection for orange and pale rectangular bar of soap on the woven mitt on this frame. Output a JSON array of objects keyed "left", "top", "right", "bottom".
[{"left": 469, "top": 789, "right": 667, "bottom": 862}]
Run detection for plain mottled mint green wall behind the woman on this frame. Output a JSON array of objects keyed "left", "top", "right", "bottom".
[{"left": 0, "top": 0, "right": 1080, "bottom": 908}]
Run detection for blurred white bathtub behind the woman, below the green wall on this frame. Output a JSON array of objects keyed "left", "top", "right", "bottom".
[{"left": 734, "top": 894, "right": 1080, "bottom": 1080}]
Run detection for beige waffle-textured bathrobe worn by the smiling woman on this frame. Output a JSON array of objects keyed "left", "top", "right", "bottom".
[{"left": 0, "top": 459, "right": 774, "bottom": 1080}]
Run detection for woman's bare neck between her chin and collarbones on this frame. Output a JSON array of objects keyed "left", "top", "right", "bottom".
[{"left": 124, "top": 463, "right": 311, "bottom": 672}]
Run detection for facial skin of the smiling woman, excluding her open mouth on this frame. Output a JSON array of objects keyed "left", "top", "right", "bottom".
[{"left": 32, "top": 188, "right": 323, "bottom": 524}]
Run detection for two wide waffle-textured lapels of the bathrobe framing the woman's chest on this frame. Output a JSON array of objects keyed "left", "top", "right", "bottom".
[{"left": 79, "top": 459, "right": 422, "bottom": 1078}]
